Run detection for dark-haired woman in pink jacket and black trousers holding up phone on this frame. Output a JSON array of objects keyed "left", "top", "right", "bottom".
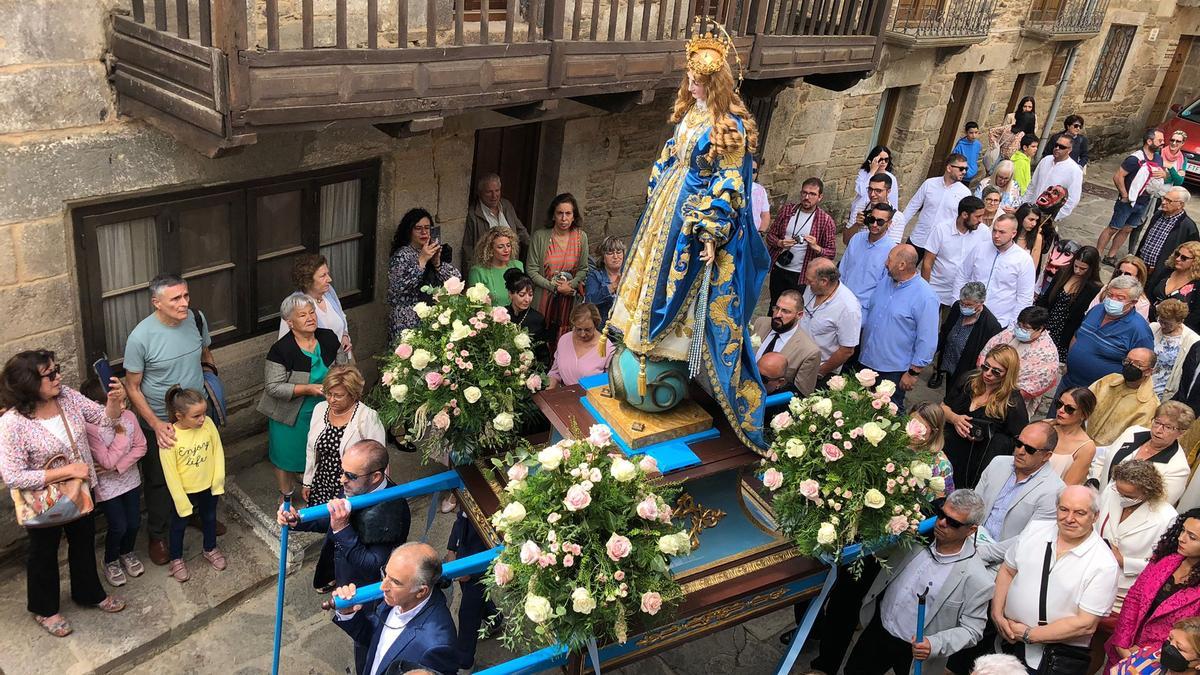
[{"left": 0, "top": 350, "right": 125, "bottom": 638}]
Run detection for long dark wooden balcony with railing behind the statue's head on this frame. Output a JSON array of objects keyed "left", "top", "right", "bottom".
[{"left": 110, "top": 0, "right": 888, "bottom": 156}]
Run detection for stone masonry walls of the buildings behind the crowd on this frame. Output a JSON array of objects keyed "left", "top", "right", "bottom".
[{"left": 0, "top": 0, "right": 1200, "bottom": 549}]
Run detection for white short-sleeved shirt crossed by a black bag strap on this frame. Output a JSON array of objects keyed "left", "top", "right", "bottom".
[{"left": 997, "top": 520, "right": 1121, "bottom": 668}]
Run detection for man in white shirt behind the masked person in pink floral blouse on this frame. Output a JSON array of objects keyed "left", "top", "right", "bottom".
[{"left": 954, "top": 214, "right": 1037, "bottom": 328}]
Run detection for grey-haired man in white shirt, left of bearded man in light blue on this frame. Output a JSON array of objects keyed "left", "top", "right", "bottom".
[{"left": 800, "top": 258, "right": 863, "bottom": 377}]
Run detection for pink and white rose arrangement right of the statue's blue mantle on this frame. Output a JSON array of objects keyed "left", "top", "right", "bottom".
[{"left": 762, "top": 370, "right": 944, "bottom": 561}]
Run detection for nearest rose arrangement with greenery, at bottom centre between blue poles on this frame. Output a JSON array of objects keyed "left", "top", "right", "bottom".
[{"left": 485, "top": 425, "right": 691, "bottom": 651}]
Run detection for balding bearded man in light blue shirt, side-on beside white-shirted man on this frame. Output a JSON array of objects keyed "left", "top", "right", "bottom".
[{"left": 858, "top": 244, "right": 938, "bottom": 410}]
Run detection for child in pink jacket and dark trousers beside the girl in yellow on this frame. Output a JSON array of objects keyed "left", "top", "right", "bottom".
[{"left": 80, "top": 377, "right": 146, "bottom": 586}]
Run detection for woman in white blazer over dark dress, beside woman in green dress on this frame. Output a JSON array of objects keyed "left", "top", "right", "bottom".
[{"left": 304, "top": 364, "right": 388, "bottom": 506}]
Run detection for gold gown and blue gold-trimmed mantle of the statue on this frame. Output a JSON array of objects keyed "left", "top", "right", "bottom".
[{"left": 610, "top": 103, "right": 770, "bottom": 450}]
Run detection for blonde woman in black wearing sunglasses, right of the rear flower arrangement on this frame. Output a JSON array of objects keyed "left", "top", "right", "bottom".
[{"left": 942, "top": 345, "right": 1030, "bottom": 489}]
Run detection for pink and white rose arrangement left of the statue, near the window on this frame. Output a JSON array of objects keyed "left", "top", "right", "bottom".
[{"left": 370, "top": 277, "right": 544, "bottom": 465}]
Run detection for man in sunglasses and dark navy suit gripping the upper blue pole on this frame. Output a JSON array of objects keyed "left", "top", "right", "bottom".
[{"left": 276, "top": 438, "right": 412, "bottom": 673}]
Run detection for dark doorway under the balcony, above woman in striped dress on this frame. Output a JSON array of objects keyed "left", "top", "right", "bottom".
[{"left": 468, "top": 123, "right": 545, "bottom": 231}]
